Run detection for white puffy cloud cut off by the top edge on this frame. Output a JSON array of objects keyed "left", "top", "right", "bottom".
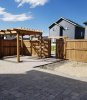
[{"left": 15, "top": 0, "right": 48, "bottom": 8}]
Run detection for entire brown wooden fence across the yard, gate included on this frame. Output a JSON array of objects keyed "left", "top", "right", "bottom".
[{"left": 0, "top": 39, "right": 87, "bottom": 62}]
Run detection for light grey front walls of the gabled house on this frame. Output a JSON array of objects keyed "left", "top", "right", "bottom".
[{"left": 49, "top": 20, "right": 75, "bottom": 39}]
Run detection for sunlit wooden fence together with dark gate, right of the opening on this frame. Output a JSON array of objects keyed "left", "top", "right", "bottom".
[{"left": 56, "top": 39, "right": 87, "bottom": 62}]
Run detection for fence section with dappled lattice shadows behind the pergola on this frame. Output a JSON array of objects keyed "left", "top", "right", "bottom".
[{"left": 23, "top": 39, "right": 51, "bottom": 57}]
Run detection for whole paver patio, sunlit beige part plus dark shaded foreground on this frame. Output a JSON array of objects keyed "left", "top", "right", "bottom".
[{"left": 0, "top": 58, "right": 87, "bottom": 100}]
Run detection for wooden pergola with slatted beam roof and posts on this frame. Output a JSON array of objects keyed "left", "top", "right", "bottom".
[{"left": 0, "top": 28, "right": 42, "bottom": 62}]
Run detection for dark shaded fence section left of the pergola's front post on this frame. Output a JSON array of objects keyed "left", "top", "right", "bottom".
[{"left": 0, "top": 40, "right": 17, "bottom": 57}]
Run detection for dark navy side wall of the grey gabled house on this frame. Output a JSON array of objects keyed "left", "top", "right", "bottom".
[{"left": 75, "top": 27, "right": 85, "bottom": 39}]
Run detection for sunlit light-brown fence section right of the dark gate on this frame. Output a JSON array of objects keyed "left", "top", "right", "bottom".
[{"left": 65, "top": 40, "right": 87, "bottom": 62}]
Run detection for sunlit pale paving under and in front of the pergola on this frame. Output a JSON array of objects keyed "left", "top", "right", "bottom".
[{"left": 0, "top": 56, "right": 57, "bottom": 74}]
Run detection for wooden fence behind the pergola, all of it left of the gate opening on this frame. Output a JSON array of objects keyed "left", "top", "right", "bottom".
[{"left": 0, "top": 39, "right": 51, "bottom": 58}]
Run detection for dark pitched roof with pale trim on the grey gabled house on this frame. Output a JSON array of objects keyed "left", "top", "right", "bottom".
[{"left": 49, "top": 17, "right": 83, "bottom": 29}]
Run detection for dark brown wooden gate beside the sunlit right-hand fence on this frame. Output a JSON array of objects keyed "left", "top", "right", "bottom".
[{"left": 56, "top": 38, "right": 64, "bottom": 59}]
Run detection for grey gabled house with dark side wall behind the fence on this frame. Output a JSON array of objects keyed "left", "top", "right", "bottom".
[{"left": 49, "top": 18, "right": 85, "bottom": 39}]
